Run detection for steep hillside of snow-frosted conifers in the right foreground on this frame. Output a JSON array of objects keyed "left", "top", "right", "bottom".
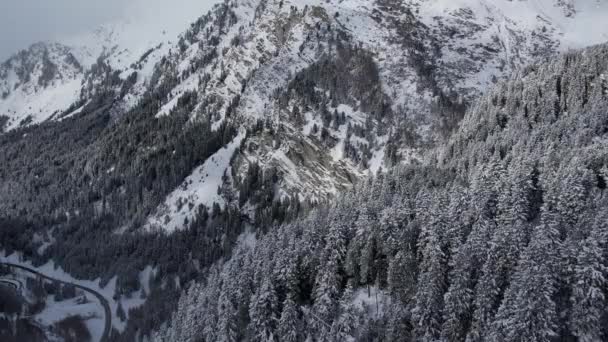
[{"left": 155, "top": 45, "right": 608, "bottom": 341}]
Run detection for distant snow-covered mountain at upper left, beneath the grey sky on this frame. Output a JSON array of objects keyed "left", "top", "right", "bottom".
[{"left": 0, "top": 0, "right": 221, "bottom": 130}]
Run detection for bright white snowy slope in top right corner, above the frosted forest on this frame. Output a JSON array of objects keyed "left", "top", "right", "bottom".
[{"left": 411, "top": 0, "right": 608, "bottom": 94}]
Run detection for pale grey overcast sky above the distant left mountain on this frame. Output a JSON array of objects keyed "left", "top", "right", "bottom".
[{"left": 0, "top": 0, "right": 217, "bottom": 61}]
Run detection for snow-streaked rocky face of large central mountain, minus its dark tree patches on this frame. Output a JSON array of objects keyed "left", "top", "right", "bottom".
[{"left": 137, "top": 0, "right": 608, "bottom": 231}]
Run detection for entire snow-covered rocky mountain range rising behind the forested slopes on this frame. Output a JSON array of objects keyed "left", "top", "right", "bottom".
[{"left": 0, "top": 0, "right": 608, "bottom": 231}]
